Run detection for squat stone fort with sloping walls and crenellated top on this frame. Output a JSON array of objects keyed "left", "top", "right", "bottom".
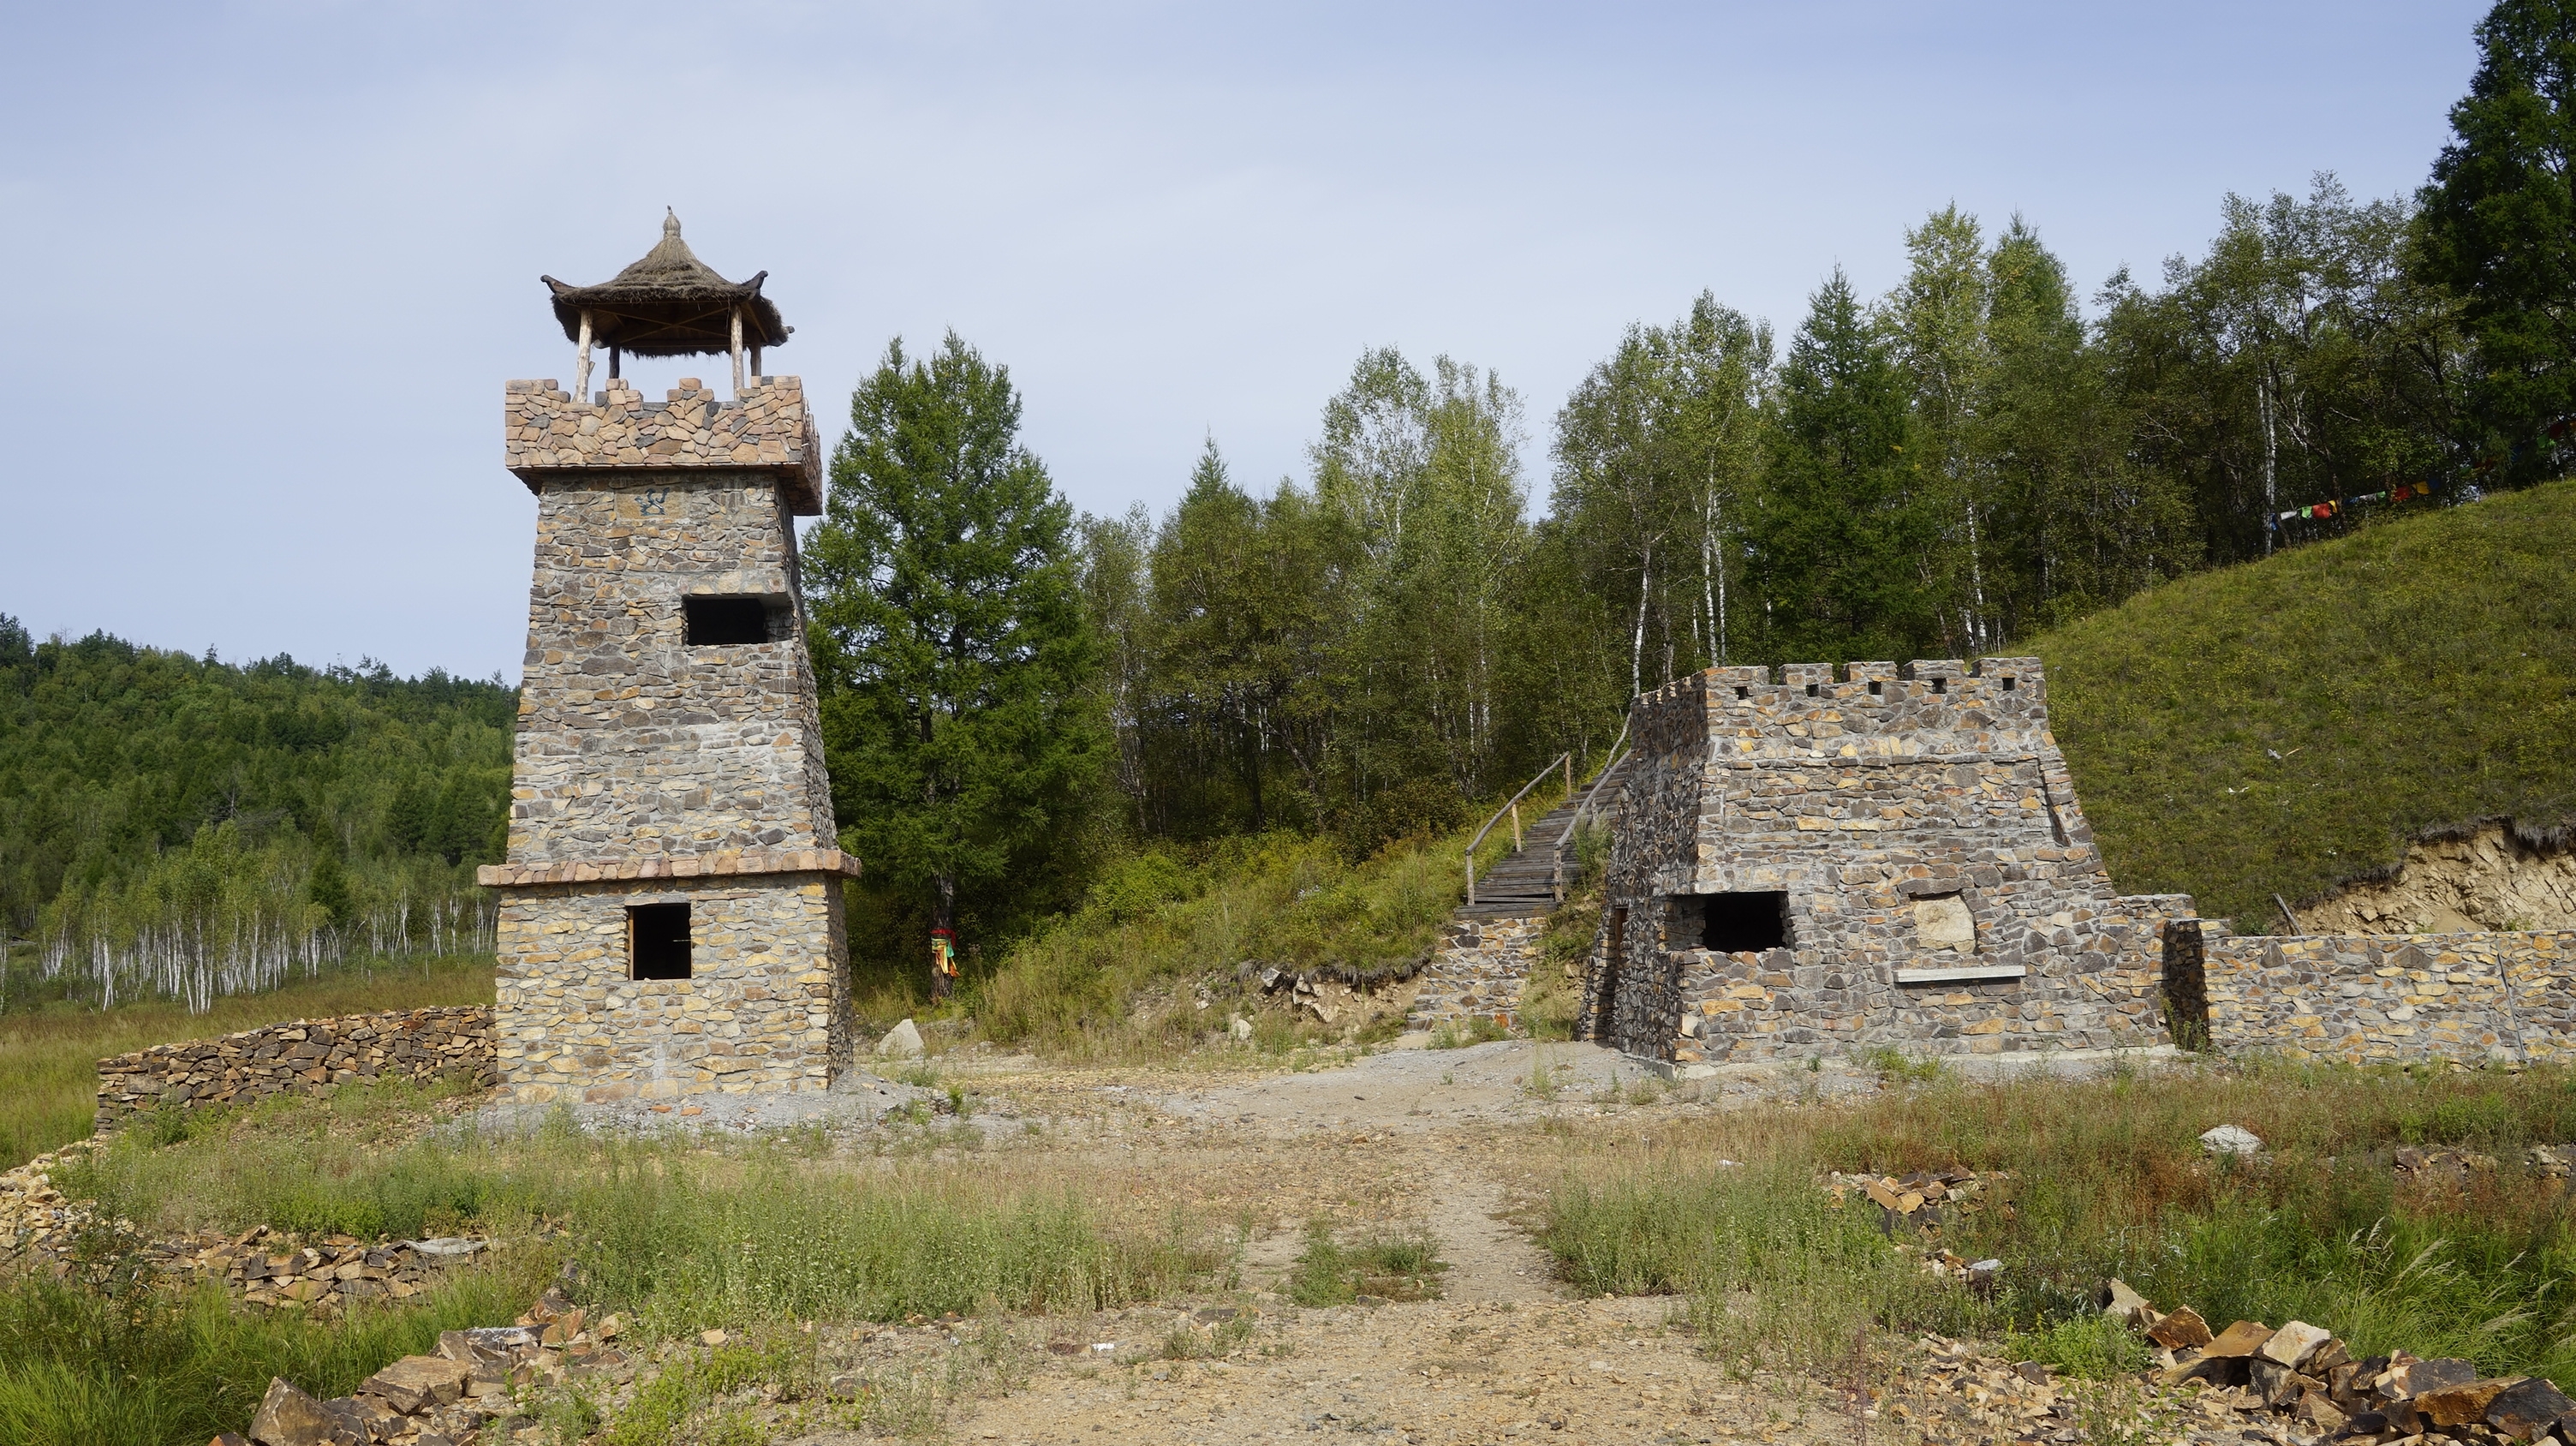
[{"left": 1577, "top": 657, "right": 2192, "bottom": 1075}]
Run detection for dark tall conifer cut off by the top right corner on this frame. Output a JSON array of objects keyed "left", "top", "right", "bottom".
[{"left": 2417, "top": 0, "right": 2576, "bottom": 482}]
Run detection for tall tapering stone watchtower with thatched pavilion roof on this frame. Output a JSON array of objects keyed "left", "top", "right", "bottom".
[{"left": 481, "top": 208, "right": 858, "bottom": 1103}]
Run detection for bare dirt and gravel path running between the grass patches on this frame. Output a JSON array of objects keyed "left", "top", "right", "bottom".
[{"left": 783, "top": 1042, "right": 1855, "bottom": 1446}]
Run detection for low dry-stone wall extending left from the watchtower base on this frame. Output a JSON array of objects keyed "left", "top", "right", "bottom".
[{"left": 95, "top": 1005, "right": 500, "bottom": 1134}]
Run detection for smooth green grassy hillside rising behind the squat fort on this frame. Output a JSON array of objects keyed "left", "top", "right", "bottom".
[{"left": 2027, "top": 482, "right": 2576, "bottom": 930}]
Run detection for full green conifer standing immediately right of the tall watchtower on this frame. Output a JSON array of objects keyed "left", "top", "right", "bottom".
[{"left": 807, "top": 332, "right": 1107, "bottom": 995}]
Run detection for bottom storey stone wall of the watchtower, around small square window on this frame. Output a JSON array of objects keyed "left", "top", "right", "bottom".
[{"left": 495, "top": 874, "right": 850, "bottom": 1103}]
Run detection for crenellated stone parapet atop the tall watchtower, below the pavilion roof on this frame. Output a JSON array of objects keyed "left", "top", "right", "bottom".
[{"left": 503, "top": 376, "right": 822, "bottom": 518}]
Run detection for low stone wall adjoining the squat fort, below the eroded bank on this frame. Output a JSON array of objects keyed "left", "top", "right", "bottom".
[{"left": 2177, "top": 920, "right": 2576, "bottom": 1062}]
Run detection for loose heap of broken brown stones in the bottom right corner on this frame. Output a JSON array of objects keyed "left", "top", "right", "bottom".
[{"left": 2102, "top": 1281, "right": 2576, "bottom": 1443}]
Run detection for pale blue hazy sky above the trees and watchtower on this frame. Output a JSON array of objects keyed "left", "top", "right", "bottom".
[{"left": 0, "top": 0, "right": 2484, "bottom": 678}]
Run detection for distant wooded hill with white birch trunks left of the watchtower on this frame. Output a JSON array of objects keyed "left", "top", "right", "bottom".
[{"left": 0, "top": 616, "right": 518, "bottom": 1007}]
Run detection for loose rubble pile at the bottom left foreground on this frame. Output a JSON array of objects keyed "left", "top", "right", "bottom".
[{"left": 212, "top": 1286, "right": 634, "bottom": 1446}]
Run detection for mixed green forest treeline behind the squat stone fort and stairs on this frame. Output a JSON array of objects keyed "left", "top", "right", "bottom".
[{"left": 1079, "top": 176, "right": 2493, "bottom": 848}]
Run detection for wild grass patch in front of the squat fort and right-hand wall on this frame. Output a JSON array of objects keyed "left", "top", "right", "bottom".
[{"left": 1543, "top": 1065, "right": 2576, "bottom": 1387}]
